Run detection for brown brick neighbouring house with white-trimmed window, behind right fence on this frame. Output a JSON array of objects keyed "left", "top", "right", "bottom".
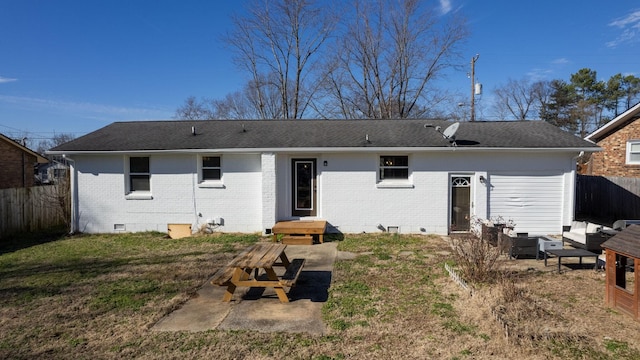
[{"left": 583, "top": 103, "right": 640, "bottom": 178}]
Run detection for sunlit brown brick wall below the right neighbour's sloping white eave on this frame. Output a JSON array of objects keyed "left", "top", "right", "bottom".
[{"left": 587, "top": 119, "right": 640, "bottom": 177}]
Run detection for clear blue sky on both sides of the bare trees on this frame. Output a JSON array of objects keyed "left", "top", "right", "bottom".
[{"left": 0, "top": 0, "right": 640, "bottom": 145}]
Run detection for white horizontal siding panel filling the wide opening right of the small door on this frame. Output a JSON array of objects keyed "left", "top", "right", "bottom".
[{"left": 489, "top": 173, "right": 564, "bottom": 235}]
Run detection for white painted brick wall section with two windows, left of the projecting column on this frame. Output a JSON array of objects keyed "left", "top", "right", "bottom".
[{"left": 76, "top": 155, "right": 262, "bottom": 233}]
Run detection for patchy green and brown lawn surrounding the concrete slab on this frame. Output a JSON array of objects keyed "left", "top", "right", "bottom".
[{"left": 0, "top": 233, "right": 638, "bottom": 360}]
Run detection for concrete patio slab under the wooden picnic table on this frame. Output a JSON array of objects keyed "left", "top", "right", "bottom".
[{"left": 152, "top": 243, "right": 338, "bottom": 335}]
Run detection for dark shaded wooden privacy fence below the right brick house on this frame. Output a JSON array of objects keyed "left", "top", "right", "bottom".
[{"left": 576, "top": 175, "right": 640, "bottom": 222}]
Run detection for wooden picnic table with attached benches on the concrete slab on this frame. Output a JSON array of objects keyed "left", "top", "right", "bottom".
[{"left": 211, "top": 243, "right": 305, "bottom": 303}]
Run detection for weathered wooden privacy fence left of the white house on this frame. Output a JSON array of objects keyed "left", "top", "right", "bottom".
[{"left": 0, "top": 185, "right": 70, "bottom": 238}]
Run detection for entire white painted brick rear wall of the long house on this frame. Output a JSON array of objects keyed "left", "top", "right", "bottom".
[{"left": 75, "top": 149, "right": 575, "bottom": 234}]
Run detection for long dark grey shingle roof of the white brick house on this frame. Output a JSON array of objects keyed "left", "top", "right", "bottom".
[{"left": 51, "top": 120, "right": 598, "bottom": 153}]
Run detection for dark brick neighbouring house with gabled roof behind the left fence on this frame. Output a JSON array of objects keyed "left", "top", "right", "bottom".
[{"left": 0, "top": 134, "right": 48, "bottom": 189}]
